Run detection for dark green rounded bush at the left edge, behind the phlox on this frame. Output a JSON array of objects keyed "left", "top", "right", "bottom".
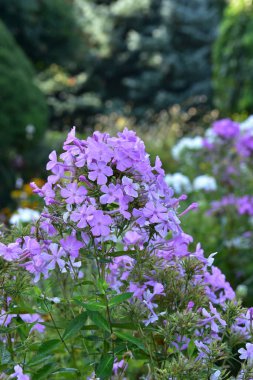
[{"left": 0, "top": 22, "right": 47, "bottom": 205}]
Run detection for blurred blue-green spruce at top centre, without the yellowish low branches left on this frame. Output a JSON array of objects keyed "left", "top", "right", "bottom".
[{"left": 74, "top": 0, "right": 218, "bottom": 116}]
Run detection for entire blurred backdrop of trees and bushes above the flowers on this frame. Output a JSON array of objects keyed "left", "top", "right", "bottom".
[{"left": 0, "top": 0, "right": 253, "bottom": 208}]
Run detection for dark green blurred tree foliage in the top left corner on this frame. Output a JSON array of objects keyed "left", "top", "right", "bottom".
[{"left": 0, "top": 0, "right": 85, "bottom": 70}]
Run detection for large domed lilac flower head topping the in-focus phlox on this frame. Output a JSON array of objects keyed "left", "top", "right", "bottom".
[{"left": 6, "top": 129, "right": 185, "bottom": 281}]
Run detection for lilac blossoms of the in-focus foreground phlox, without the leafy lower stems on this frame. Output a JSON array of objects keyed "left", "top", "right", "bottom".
[{"left": 0, "top": 127, "right": 252, "bottom": 380}]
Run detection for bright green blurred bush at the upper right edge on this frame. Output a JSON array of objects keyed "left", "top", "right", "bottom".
[{"left": 213, "top": 0, "right": 253, "bottom": 115}]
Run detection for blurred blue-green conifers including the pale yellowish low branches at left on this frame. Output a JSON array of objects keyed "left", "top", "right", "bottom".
[{"left": 35, "top": 0, "right": 219, "bottom": 128}]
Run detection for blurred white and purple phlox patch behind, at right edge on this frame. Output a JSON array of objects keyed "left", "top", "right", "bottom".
[{"left": 169, "top": 116, "right": 253, "bottom": 303}]
